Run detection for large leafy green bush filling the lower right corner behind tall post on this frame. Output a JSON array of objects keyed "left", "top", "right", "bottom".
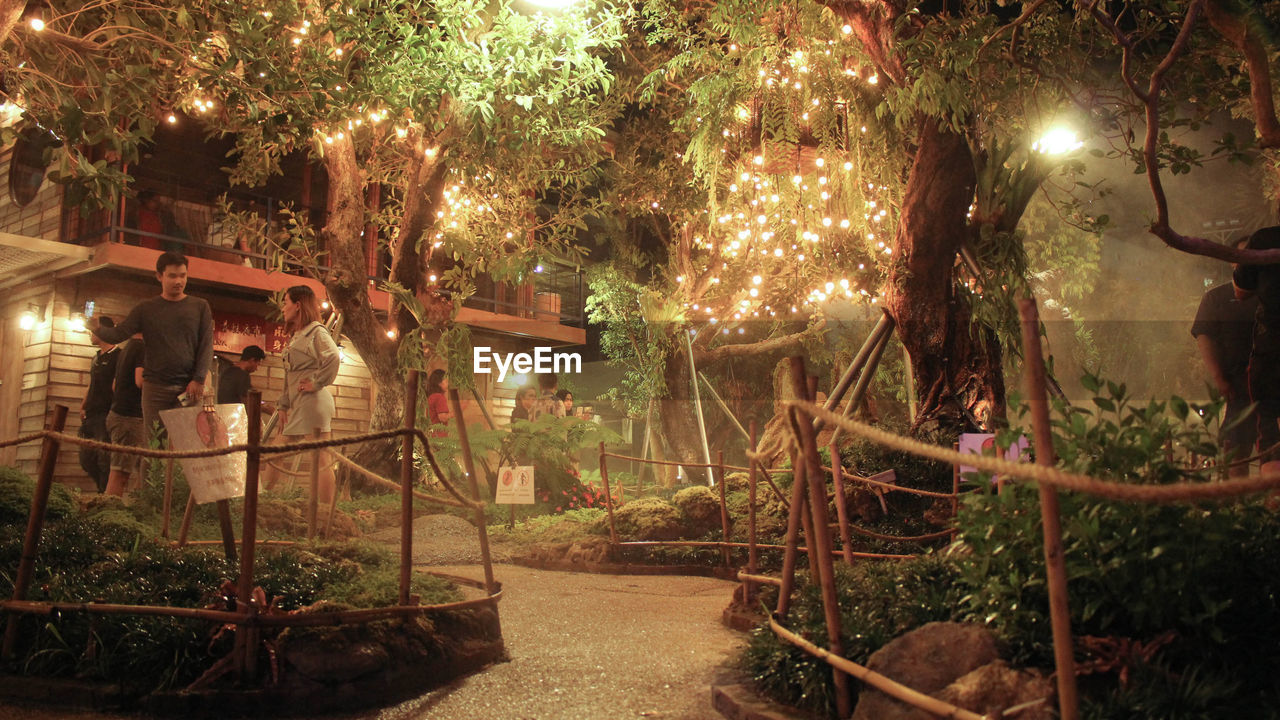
[{"left": 959, "top": 378, "right": 1280, "bottom": 717}]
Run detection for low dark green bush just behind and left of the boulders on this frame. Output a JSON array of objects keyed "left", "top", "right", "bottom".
[{"left": 744, "top": 555, "right": 959, "bottom": 716}]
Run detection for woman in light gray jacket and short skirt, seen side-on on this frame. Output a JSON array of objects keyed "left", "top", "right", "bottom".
[{"left": 276, "top": 284, "right": 339, "bottom": 505}]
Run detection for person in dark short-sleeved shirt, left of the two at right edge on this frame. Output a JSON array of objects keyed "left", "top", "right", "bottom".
[{"left": 1192, "top": 238, "right": 1258, "bottom": 477}]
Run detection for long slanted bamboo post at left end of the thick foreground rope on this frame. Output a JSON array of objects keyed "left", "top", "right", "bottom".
[{"left": 791, "top": 356, "right": 849, "bottom": 717}]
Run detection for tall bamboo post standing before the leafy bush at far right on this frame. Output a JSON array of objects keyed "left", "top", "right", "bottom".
[{"left": 1018, "top": 297, "right": 1080, "bottom": 720}]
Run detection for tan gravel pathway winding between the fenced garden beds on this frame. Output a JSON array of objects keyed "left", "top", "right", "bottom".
[{"left": 0, "top": 515, "right": 745, "bottom": 720}]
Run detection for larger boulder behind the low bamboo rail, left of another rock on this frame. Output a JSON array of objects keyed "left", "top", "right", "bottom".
[{"left": 852, "top": 623, "right": 1000, "bottom": 720}]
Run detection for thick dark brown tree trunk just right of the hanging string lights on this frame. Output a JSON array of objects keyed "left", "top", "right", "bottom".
[{"left": 884, "top": 120, "right": 1005, "bottom": 429}]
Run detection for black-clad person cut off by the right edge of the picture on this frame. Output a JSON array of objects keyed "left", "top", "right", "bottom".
[{"left": 1231, "top": 225, "right": 1280, "bottom": 474}]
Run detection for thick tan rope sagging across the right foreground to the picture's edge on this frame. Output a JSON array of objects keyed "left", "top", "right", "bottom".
[{"left": 786, "top": 400, "right": 1280, "bottom": 503}]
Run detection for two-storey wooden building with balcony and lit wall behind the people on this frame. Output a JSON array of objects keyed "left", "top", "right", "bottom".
[{"left": 0, "top": 121, "right": 586, "bottom": 489}]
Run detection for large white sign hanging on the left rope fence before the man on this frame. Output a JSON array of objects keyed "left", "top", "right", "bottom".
[{"left": 160, "top": 404, "right": 248, "bottom": 505}]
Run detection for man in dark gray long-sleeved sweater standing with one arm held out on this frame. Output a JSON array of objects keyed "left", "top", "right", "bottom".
[{"left": 93, "top": 252, "right": 214, "bottom": 443}]
